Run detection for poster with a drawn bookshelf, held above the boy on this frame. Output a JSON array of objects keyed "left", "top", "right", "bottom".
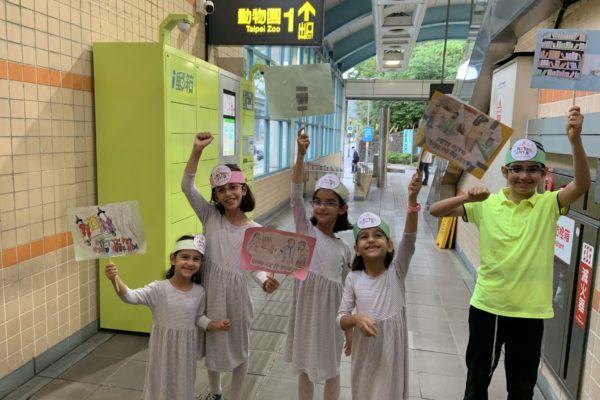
[{"left": 531, "top": 29, "right": 600, "bottom": 92}]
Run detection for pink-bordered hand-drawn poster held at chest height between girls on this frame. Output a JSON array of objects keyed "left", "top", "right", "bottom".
[{"left": 241, "top": 228, "right": 316, "bottom": 281}]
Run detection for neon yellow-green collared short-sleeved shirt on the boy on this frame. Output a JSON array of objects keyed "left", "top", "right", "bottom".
[{"left": 464, "top": 188, "right": 568, "bottom": 318}]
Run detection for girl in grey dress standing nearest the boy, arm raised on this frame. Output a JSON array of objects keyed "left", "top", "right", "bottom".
[{"left": 337, "top": 171, "right": 421, "bottom": 400}]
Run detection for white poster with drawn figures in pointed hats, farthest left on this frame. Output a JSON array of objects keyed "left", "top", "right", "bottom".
[{"left": 67, "top": 201, "right": 146, "bottom": 261}]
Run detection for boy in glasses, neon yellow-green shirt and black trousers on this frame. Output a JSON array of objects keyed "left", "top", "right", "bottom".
[{"left": 430, "top": 106, "right": 591, "bottom": 400}]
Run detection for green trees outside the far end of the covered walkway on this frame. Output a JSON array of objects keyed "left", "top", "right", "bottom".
[{"left": 348, "top": 40, "right": 465, "bottom": 136}]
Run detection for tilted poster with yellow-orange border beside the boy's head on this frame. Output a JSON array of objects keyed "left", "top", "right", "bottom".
[{"left": 417, "top": 92, "right": 513, "bottom": 178}]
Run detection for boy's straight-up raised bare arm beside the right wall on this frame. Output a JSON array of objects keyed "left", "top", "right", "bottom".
[{"left": 558, "top": 106, "right": 592, "bottom": 207}]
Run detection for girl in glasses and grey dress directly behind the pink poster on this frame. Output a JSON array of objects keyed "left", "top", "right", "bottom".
[{"left": 285, "top": 127, "right": 352, "bottom": 400}]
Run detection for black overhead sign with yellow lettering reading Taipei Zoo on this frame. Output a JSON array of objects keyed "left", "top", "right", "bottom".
[{"left": 208, "top": 0, "right": 324, "bottom": 46}]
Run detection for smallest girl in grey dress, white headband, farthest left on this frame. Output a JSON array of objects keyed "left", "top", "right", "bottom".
[{"left": 105, "top": 235, "right": 229, "bottom": 400}]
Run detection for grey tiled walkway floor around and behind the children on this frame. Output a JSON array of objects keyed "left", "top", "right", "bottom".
[{"left": 0, "top": 153, "right": 543, "bottom": 400}]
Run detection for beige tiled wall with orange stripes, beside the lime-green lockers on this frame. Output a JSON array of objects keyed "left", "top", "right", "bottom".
[{"left": 0, "top": 0, "right": 212, "bottom": 378}]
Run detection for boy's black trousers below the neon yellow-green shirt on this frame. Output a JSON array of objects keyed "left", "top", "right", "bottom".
[{"left": 464, "top": 306, "right": 544, "bottom": 400}]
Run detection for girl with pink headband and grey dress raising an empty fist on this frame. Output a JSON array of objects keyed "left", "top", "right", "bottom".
[{"left": 181, "top": 132, "right": 279, "bottom": 400}]
